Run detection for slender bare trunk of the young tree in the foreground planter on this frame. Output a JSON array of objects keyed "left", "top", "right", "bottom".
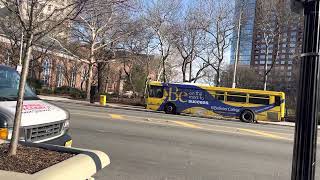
[{"left": 9, "top": 34, "right": 33, "bottom": 156}]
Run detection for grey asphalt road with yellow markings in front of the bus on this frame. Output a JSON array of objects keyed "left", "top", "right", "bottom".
[{"left": 50, "top": 103, "right": 320, "bottom": 180}]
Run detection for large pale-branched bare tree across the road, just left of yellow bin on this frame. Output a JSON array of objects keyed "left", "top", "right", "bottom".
[{"left": 56, "top": 0, "right": 133, "bottom": 99}]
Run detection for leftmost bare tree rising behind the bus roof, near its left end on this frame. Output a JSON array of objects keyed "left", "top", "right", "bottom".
[{"left": 144, "top": 0, "right": 181, "bottom": 82}]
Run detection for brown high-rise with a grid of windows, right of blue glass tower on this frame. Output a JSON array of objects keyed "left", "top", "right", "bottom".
[{"left": 251, "top": 0, "right": 303, "bottom": 87}]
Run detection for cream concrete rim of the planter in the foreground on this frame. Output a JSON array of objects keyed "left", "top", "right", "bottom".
[{"left": 0, "top": 142, "right": 110, "bottom": 180}]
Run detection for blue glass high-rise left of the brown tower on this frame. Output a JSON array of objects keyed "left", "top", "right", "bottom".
[{"left": 230, "top": 0, "right": 256, "bottom": 65}]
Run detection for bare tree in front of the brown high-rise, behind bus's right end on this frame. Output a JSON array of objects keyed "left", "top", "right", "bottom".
[{"left": 256, "top": 0, "right": 292, "bottom": 90}]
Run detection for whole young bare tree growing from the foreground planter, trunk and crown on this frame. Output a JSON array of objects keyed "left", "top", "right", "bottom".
[{"left": 0, "top": 0, "right": 84, "bottom": 155}]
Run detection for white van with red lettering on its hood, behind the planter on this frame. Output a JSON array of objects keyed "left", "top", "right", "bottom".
[{"left": 0, "top": 65, "right": 72, "bottom": 146}]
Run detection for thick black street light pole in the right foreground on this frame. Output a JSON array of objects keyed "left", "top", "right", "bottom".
[{"left": 291, "top": 0, "right": 320, "bottom": 180}]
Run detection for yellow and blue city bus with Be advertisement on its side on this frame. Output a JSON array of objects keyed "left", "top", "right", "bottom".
[{"left": 146, "top": 81, "right": 285, "bottom": 123}]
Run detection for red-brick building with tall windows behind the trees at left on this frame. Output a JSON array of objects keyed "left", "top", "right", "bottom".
[{"left": 0, "top": 36, "right": 156, "bottom": 94}]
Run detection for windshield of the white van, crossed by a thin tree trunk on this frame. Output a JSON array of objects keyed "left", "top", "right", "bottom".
[{"left": 0, "top": 66, "right": 39, "bottom": 101}]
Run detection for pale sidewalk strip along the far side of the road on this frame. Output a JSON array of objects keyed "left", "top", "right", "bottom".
[{"left": 38, "top": 95, "right": 320, "bottom": 129}]
